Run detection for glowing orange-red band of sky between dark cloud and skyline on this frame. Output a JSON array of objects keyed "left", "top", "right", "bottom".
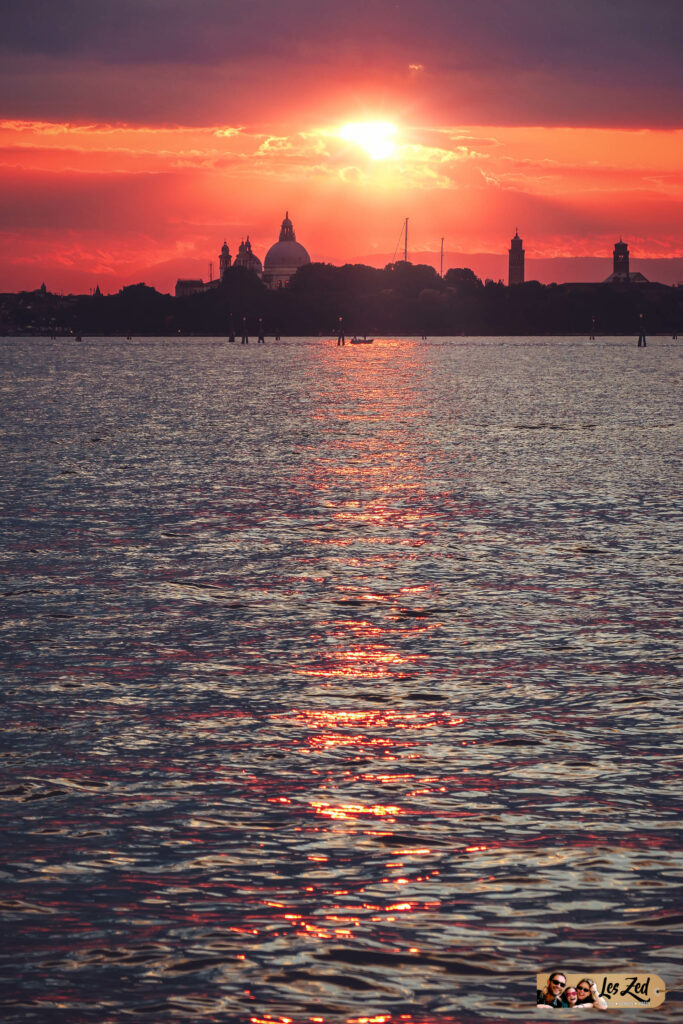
[{"left": 0, "top": 115, "right": 683, "bottom": 290}]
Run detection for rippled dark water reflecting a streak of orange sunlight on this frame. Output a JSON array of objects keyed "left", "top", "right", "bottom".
[{"left": 0, "top": 338, "right": 683, "bottom": 1024}]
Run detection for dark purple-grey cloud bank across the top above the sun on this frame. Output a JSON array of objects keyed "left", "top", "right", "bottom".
[{"left": 0, "top": 0, "right": 683, "bottom": 126}]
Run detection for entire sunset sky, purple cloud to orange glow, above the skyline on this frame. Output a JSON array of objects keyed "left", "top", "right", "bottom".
[{"left": 0, "top": 0, "right": 683, "bottom": 292}]
